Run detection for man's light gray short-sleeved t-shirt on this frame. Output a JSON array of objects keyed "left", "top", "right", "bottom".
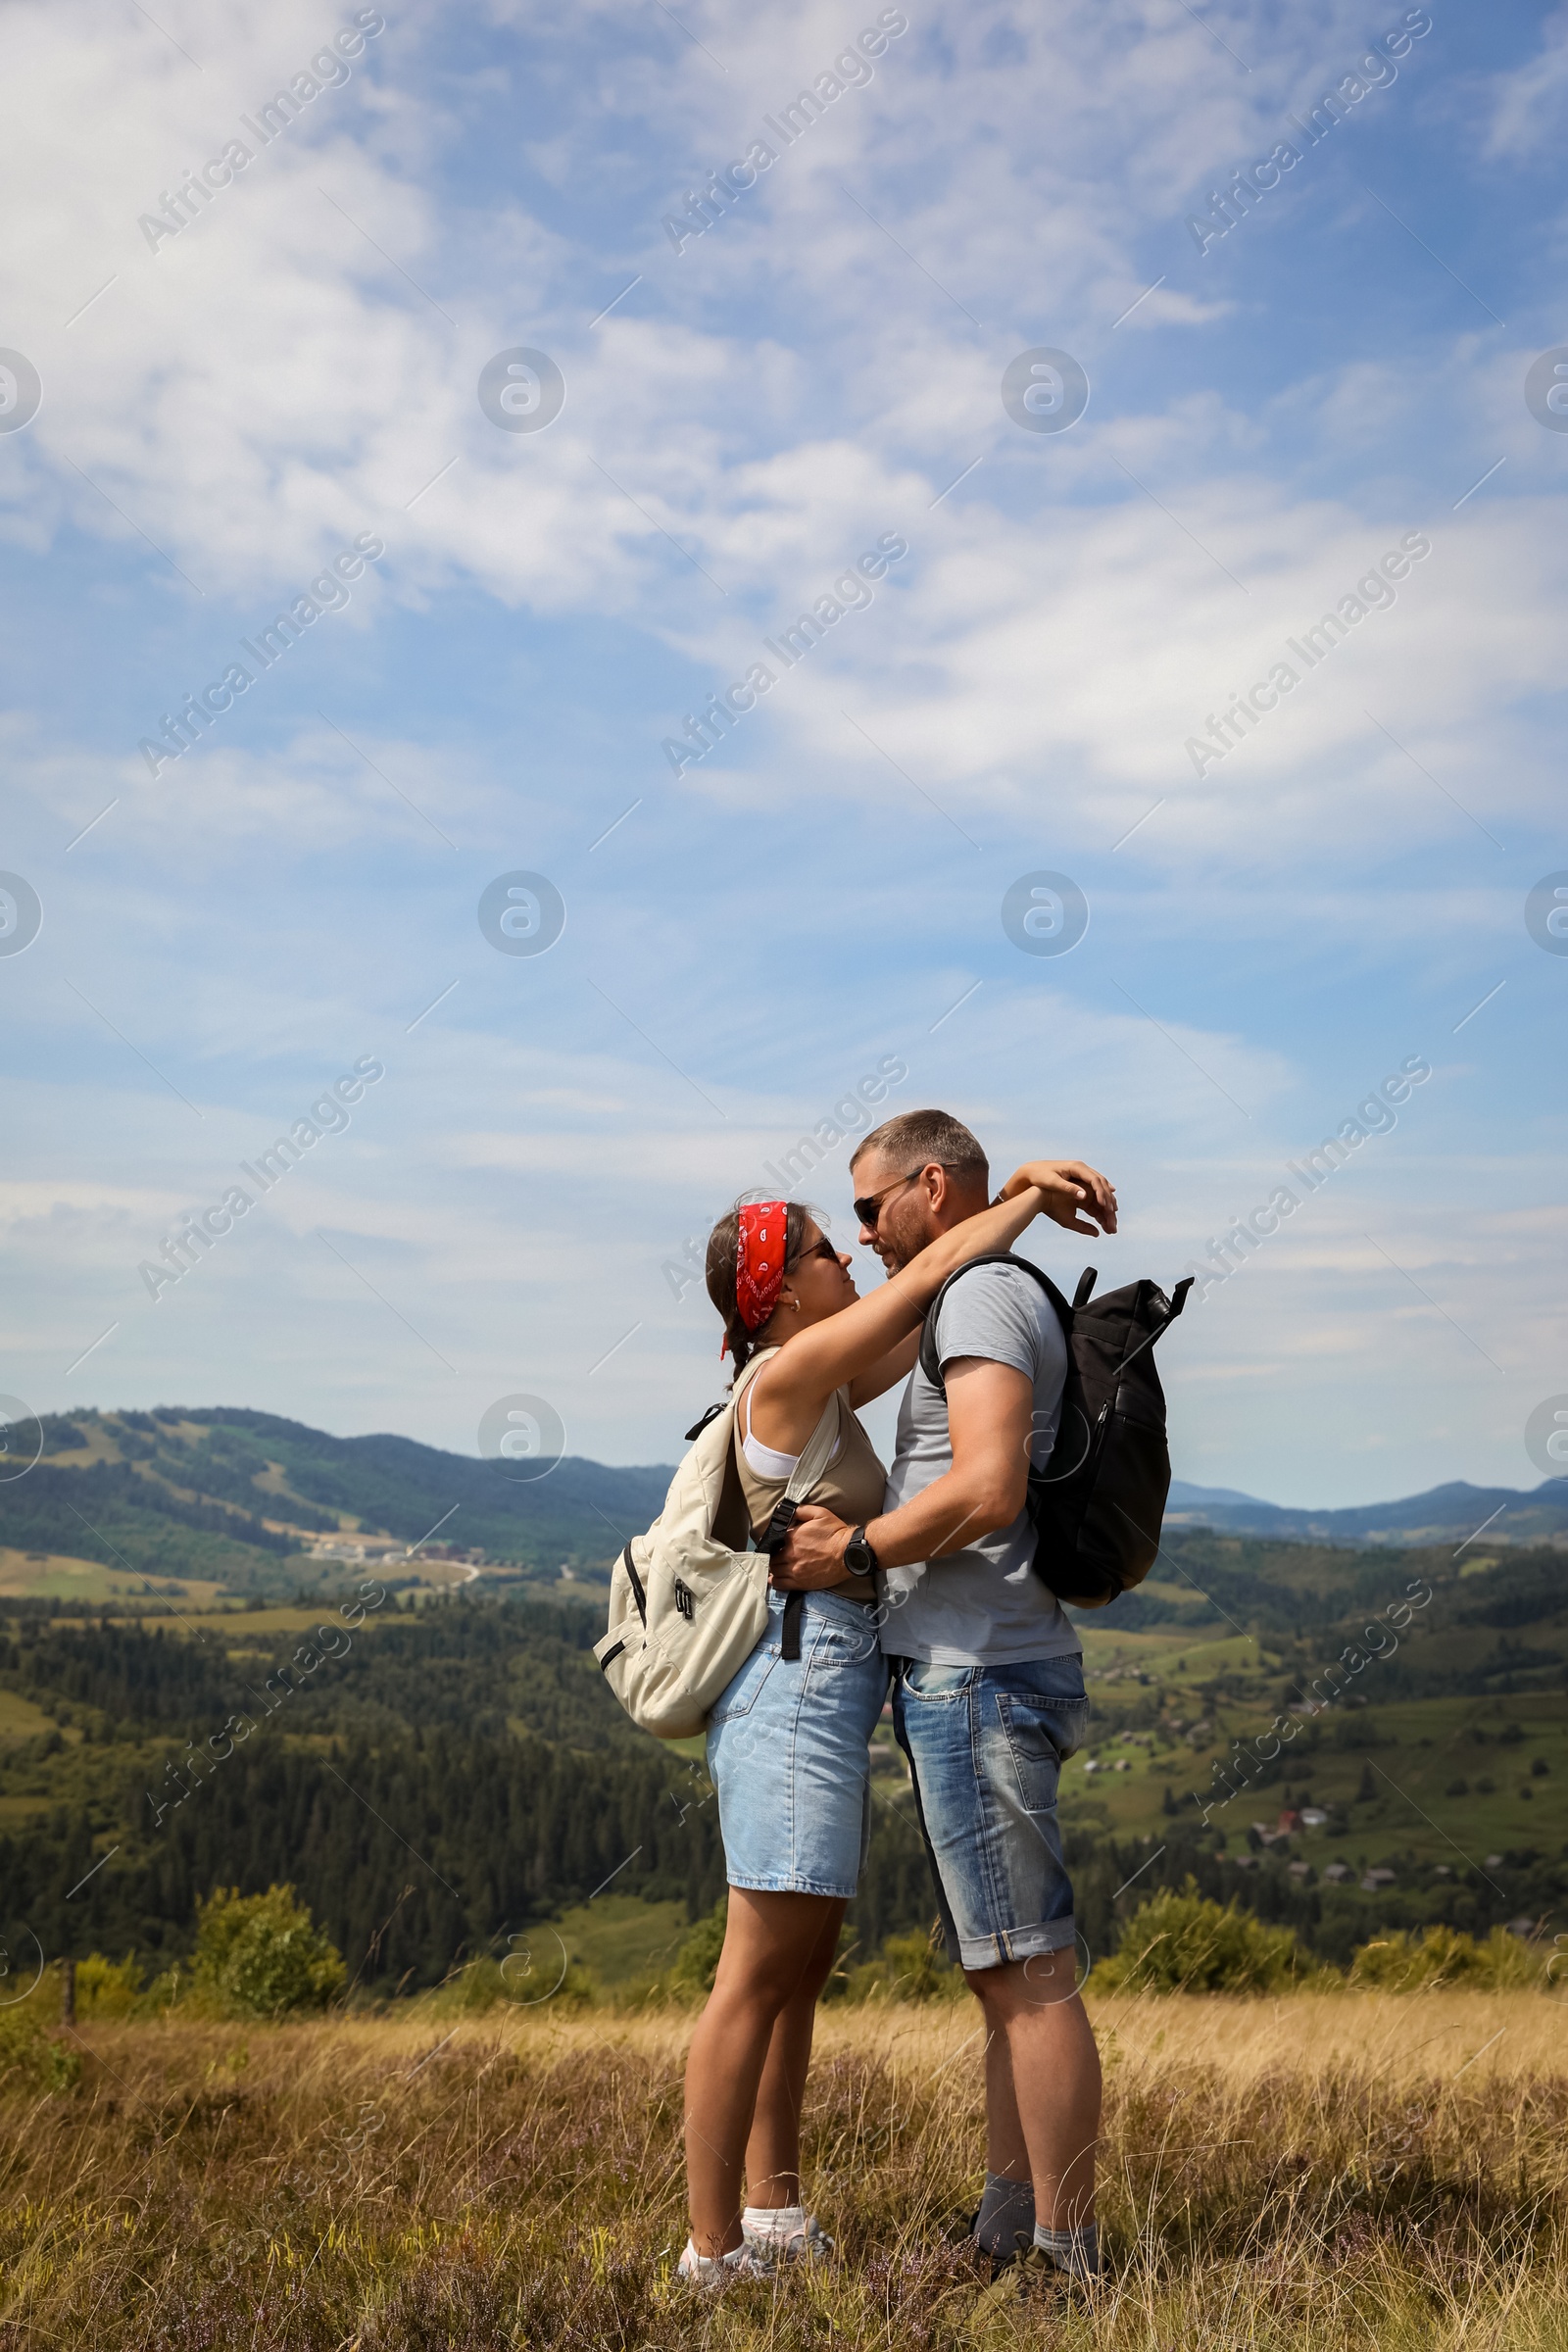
[{"left": 882, "top": 1265, "right": 1081, "bottom": 1665}]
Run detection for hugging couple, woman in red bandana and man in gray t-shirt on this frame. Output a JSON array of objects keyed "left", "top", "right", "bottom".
[{"left": 679, "top": 1110, "right": 1116, "bottom": 2286}]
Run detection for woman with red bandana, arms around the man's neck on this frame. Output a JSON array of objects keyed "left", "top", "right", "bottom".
[{"left": 679, "top": 1159, "right": 1114, "bottom": 2286}]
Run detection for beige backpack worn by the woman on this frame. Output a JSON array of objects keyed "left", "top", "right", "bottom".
[{"left": 592, "top": 1348, "right": 839, "bottom": 1740}]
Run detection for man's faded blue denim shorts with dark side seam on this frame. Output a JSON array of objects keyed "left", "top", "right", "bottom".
[{"left": 894, "top": 1656, "right": 1089, "bottom": 1969}]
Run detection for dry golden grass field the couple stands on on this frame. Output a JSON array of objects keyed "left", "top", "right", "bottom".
[{"left": 0, "top": 1992, "right": 1568, "bottom": 2352}]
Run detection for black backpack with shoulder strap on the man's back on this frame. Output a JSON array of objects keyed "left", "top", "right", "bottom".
[{"left": 919, "top": 1251, "right": 1192, "bottom": 1609}]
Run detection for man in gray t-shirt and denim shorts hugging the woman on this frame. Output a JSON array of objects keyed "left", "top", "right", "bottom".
[{"left": 776, "top": 1110, "right": 1116, "bottom": 2277}]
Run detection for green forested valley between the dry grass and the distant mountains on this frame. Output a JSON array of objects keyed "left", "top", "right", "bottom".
[{"left": 0, "top": 1472, "right": 1568, "bottom": 1994}]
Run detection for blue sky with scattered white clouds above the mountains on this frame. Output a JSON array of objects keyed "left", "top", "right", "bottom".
[{"left": 0, "top": 0, "right": 1568, "bottom": 1505}]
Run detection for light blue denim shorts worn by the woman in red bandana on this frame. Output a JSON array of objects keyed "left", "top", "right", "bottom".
[{"left": 708, "top": 1592, "right": 889, "bottom": 1898}]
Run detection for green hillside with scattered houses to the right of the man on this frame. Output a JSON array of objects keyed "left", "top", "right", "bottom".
[{"left": 1060, "top": 1539, "right": 1568, "bottom": 1964}]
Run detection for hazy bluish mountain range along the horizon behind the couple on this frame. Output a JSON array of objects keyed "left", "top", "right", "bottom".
[{"left": 0, "top": 1406, "right": 1568, "bottom": 1597}]
